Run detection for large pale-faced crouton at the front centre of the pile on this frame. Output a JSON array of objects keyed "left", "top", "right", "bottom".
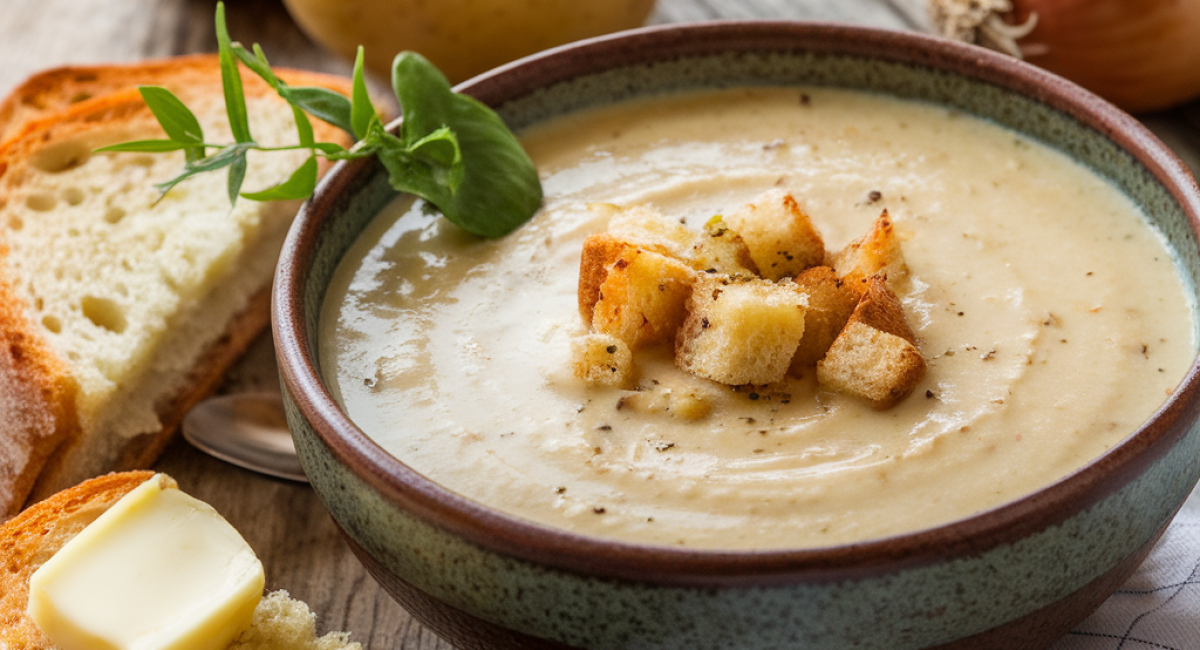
[{"left": 676, "top": 276, "right": 805, "bottom": 385}]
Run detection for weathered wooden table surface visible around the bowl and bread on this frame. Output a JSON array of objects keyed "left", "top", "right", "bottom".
[{"left": 0, "top": 0, "right": 1200, "bottom": 650}]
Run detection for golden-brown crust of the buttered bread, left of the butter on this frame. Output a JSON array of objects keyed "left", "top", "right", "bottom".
[{"left": 0, "top": 471, "right": 155, "bottom": 650}]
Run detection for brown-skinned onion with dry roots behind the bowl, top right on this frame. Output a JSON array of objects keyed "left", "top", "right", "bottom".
[{"left": 929, "top": 0, "right": 1200, "bottom": 113}]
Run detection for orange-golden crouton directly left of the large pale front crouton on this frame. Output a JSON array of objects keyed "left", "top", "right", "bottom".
[{"left": 592, "top": 247, "right": 696, "bottom": 348}]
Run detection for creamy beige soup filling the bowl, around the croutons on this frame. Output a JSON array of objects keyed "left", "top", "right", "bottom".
[{"left": 320, "top": 88, "right": 1194, "bottom": 548}]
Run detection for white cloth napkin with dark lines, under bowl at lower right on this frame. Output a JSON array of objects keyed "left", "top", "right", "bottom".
[{"left": 1052, "top": 488, "right": 1200, "bottom": 650}]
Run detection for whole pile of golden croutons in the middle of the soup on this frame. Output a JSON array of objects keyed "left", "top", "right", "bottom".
[{"left": 572, "top": 189, "right": 925, "bottom": 415}]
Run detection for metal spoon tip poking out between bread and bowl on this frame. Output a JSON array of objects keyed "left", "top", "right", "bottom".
[{"left": 182, "top": 392, "right": 308, "bottom": 482}]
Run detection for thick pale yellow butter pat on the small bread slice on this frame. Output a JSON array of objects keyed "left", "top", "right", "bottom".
[{"left": 28, "top": 475, "right": 264, "bottom": 650}]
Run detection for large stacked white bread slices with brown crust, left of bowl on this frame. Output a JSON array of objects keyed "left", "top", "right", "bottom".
[{"left": 0, "top": 55, "right": 349, "bottom": 516}]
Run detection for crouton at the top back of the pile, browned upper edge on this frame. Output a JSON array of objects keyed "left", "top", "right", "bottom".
[{"left": 725, "top": 189, "right": 826, "bottom": 279}]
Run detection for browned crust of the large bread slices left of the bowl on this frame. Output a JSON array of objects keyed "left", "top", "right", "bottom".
[{"left": 0, "top": 54, "right": 350, "bottom": 519}]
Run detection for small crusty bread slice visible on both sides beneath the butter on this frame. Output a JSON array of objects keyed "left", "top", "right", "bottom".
[{"left": 0, "top": 471, "right": 361, "bottom": 650}]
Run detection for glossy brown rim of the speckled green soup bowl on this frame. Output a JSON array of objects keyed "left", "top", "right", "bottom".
[{"left": 271, "top": 20, "right": 1200, "bottom": 586}]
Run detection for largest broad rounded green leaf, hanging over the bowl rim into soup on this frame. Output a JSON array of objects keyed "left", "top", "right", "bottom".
[{"left": 391, "top": 52, "right": 541, "bottom": 237}]
